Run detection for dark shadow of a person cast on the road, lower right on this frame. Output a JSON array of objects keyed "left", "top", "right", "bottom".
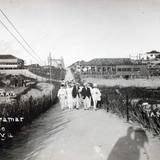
[{"left": 107, "top": 127, "right": 149, "bottom": 160}]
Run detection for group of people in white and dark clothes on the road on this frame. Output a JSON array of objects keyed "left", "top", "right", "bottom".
[{"left": 57, "top": 81, "right": 101, "bottom": 110}]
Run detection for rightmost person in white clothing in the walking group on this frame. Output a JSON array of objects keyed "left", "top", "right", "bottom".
[{"left": 91, "top": 84, "right": 101, "bottom": 110}]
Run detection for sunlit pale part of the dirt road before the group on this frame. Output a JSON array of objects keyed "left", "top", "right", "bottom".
[{"left": 21, "top": 109, "right": 160, "bottom": 160}]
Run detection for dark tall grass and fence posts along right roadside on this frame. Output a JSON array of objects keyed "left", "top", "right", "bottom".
[{"left": 100, "top": 86, "right": 160, "bottom": 135}]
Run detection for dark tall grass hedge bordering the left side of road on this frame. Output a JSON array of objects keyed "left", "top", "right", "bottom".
[{"left": 0, "top": 82, "right": 60, "bottom": 134}]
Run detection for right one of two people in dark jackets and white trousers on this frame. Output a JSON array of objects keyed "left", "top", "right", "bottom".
[{"left": 81, "top": 83, "right": 91, "bottom": 110}]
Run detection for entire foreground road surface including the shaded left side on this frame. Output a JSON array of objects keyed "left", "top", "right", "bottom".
[{"left": 0, "top": 104, "right": 160, "bottom": 160}]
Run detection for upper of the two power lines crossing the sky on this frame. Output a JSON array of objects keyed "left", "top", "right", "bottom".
[{"left": 0, "top": 9, "right": 43, "bottom": 63}]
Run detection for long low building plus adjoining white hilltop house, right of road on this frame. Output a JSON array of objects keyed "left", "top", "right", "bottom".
[{"left": 71, "top": 51, "right": 160, "bottom": 79}]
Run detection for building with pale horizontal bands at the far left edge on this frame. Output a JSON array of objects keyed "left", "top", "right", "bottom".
[{"left": 0, "top": 54, "right": 24, "bottom": 69}]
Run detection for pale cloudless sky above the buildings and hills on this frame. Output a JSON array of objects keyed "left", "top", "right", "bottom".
[{"left": 0, "top": 0, "right": 160, "bottom": 66}]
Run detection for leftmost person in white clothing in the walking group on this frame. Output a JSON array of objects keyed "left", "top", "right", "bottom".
[{"left": 57, "top": 83, "right": 67, "bottom": 110}]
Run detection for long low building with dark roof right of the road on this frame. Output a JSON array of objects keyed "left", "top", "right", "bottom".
[{"left": 73, "top": 58, "right": 149, "bottom": 78}]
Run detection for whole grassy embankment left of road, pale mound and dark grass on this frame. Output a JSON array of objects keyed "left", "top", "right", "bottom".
[{"left": 0, "top": 72, "right": 62, "bottom": 132}]
